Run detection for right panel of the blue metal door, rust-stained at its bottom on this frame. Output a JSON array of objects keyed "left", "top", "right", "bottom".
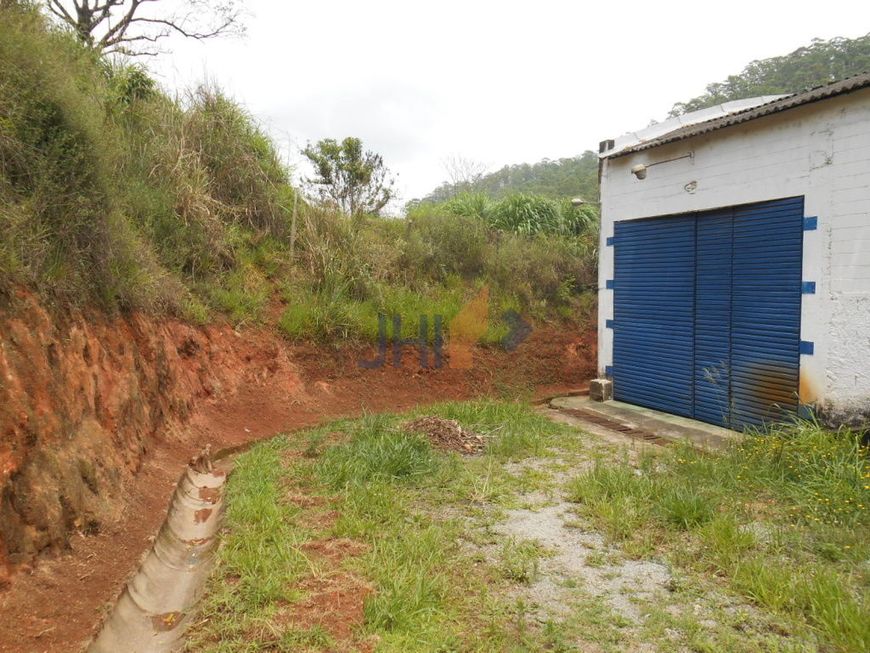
[{"left": 731, "top": 197, "right": 804, "bottom": 429}]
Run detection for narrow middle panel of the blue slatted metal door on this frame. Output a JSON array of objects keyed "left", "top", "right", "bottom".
[{"left": 693, "top": 209, "right": 733, "bottom": 426}]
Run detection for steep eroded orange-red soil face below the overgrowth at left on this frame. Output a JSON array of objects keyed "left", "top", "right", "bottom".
[{"left": 0, "top": 294, "right": 303, "bottom": 572}]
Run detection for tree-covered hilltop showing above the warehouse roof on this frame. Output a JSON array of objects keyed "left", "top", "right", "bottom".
[{"left": 670, "top": 34, "right": 870, "bottom": 117}]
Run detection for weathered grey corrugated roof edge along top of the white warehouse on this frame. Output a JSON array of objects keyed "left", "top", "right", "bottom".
[{"left": 600, "top": 73, "right": 870, "bottom": 159}]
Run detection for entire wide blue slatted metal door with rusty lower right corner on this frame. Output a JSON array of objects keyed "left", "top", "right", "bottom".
[{"left": 613, "top": 198, "right": 804, "bottom": 430}]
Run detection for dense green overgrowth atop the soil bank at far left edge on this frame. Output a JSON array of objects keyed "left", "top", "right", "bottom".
[{"left": 0, "top": 3, "right": 164, "bottom": 306}]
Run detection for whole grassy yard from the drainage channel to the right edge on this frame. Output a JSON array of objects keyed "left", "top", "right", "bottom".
[{"left": 188, "top": 400, "right": 868, "bottom": 653}]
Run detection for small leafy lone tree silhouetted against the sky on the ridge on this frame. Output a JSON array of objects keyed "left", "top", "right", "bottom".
[{"left": 302, "top": 137, "right": 395, "bottom": 215}]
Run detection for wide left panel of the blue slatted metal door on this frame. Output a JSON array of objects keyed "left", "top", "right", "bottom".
[{"left": 613, "top": 216, "right": 695, "bottom": 417}]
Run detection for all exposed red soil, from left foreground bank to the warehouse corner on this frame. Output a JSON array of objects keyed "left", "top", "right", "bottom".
[{"left": 0, "top": 292, "right": 595, "bottom": 653}]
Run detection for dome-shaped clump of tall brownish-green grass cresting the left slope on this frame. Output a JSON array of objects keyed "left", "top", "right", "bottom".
[{"left": 119, "top": 81, "right": 294, "bottom": 286}]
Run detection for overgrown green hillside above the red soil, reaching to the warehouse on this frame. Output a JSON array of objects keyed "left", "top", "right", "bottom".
[{"left": 0, "top": 3, "right": 596, "bottom": 342}]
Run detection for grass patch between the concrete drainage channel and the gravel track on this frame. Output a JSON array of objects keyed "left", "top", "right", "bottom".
[{"left": 187, "top": 401, "right": 570, "bottom": 652}]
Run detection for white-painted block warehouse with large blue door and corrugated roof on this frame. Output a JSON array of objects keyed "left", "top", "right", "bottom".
[{"left": 598, "top": 74, "right": 870, "bottom": 430}]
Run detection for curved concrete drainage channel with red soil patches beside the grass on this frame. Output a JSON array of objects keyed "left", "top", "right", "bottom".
[{"left": 87, "top": 448, "right": 227, "bottom": 653}]
